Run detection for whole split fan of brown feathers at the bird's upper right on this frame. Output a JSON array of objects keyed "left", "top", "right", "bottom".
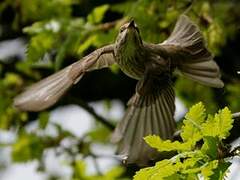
[{"left": 162, "top": 15, "right": 224, "bottom": 88}]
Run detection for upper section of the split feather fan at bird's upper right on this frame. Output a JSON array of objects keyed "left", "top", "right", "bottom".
[{"left": 159, "top": 15, "right": 213, "bottom": 63}]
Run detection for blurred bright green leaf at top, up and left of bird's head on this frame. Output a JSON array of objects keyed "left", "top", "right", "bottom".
[{"left": 87, "top": 4, "right": 110, "bottom": 24}]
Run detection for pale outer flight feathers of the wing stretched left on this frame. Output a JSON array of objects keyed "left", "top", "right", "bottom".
[{"left": 14, "top": 65, "right": 83, "bottom": 111}]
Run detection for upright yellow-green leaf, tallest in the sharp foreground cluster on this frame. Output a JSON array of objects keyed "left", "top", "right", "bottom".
[{"left": 181, "top": 102, "right": 206, "bottom": 146}]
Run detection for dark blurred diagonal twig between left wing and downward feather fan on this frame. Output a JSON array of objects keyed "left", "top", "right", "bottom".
[{"left": 69, "top": 97, "right": 115, "bottom": 130}]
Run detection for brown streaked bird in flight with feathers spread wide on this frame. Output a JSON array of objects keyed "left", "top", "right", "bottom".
[{"left": 13, "top": 14, "right": 224, "bottom": 166}]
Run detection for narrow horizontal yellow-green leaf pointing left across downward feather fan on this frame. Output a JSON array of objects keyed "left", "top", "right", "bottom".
[{"left": 144, "top": 135, "right": 191, "bottom": 152}]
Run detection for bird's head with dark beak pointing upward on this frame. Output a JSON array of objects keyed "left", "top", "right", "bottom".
[{"left": 116, "top": 20, "right": 142, "bottom": 48}]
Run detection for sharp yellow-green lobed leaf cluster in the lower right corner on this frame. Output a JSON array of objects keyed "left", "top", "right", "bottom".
[{"left": 134, "top": 102, "right": 233, "bottom": 180}]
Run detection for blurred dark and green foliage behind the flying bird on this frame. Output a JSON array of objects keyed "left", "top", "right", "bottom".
[{"left": 0, "top": 0, "right": 240, "bottom": 179}]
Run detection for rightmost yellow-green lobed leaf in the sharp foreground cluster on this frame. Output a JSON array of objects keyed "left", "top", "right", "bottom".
[{"left": 202, "top": 107, "right": 233, "bottom": 139}]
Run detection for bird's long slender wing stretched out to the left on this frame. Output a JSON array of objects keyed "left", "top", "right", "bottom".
[{"left": 14, "top": 45, "right": 115, "bottom": 111}]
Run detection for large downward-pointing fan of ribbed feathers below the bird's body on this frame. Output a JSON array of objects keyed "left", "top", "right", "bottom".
[{"left": 112, "top": 85, "right": 175, "bottom": 165}]
